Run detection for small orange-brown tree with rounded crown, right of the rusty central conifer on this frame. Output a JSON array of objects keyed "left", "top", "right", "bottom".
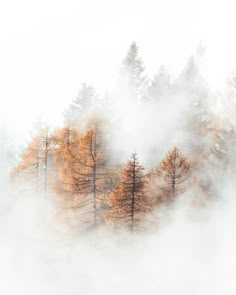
[{"left": 160, "top": 147, "right": 190, "bottom": 200}]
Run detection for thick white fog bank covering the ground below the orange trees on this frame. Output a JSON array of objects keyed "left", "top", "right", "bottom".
[{"left": 0, "top": 185, "right": 236, "bottom": 294}]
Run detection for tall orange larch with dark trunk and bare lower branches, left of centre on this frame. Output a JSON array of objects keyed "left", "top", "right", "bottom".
[{"left": 69, "top": 120, "right": 109, "bottom": 228}]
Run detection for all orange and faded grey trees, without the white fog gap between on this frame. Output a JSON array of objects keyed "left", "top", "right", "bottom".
[{"left": 12, "top": 42, "right": 235, "bottom": 232}]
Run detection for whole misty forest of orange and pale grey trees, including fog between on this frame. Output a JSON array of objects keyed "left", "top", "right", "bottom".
[{"left": 9, "top": 42, "right": 236, "bottom": 237}]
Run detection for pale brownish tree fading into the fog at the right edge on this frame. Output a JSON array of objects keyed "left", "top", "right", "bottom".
[{"left": 191, "top": 113, "right": 236, "bottom": 204}]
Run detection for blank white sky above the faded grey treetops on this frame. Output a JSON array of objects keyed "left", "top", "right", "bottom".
[{"left": 0, "top": 0, "right": 236, "bottom": 141}]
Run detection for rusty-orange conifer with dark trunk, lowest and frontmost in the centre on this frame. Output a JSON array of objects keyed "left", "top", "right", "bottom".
[{"left": 106, "top": 154, "right": 148, "bottom": 232}]
